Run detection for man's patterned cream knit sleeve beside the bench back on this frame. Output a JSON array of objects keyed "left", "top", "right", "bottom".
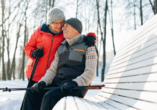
[{"left": 73, "top": 46, "right": 98, "bottom": 86}]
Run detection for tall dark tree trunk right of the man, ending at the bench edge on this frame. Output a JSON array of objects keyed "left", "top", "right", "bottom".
[{"left": 101, "top": 0, "right": 108, "bottom": 81}]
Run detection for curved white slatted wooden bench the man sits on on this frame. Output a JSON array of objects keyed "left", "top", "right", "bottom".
[{"left": 53, "top": 15, "right": 157, "bottom": 110}]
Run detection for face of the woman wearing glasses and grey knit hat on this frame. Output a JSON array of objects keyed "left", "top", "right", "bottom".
[{"left": 50, "top": 20, "right": 64, "bottom": 32}]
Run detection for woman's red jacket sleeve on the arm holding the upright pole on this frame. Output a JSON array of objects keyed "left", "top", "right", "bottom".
[{"left": 24, "top": 28, "right": 40, "bottom": 59}]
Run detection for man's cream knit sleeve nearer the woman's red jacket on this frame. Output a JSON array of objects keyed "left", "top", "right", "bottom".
[{"left": 39, "top": 52, "right": 59, "bottom": 85}]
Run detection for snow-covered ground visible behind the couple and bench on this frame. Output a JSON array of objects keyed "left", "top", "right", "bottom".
[{"left": 0, "top": 77, "right": 102, "bottom": 110}]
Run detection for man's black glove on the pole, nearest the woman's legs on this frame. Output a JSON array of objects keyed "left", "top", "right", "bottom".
[{"left": 31, "top": 81, "right": 46, "bottom": 93}]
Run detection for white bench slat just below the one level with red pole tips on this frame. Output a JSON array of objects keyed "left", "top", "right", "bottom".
[{"left": 99, "top": 88, "right": 157, "bottom": 103}]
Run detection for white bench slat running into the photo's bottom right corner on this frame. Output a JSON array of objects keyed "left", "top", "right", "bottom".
[{"left": 96, "top": 93, "right": 157, "bottom": 110}]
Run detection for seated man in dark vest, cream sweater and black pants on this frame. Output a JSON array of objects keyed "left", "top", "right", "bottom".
[{"left": 24, "top": 18, "right": 97, "bottom": 110}]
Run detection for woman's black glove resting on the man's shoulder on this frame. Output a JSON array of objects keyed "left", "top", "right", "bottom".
[{"left": 84, "top": 34, "right": 95, "bottom": 47}]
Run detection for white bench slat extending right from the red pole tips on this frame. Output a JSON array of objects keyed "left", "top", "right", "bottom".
[{"left": 105, "top": 82, "right": 157, "bottom": 92}]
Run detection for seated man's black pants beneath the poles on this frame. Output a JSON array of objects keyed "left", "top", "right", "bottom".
[{"left": 22, "top": 83, "right": 83, "bottom": 110}]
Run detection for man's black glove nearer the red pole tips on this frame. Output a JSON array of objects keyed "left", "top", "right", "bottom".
[{"left": 61, "top": 81, "right": 78, "bottom": 93}]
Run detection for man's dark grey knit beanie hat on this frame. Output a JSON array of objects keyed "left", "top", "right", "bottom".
[{"left": 65, "top": 18, "right": 82, "bottom": 34}]
